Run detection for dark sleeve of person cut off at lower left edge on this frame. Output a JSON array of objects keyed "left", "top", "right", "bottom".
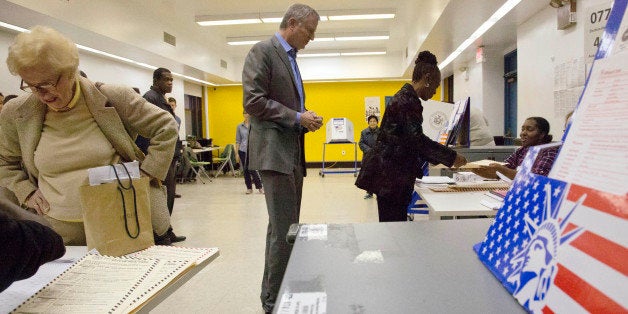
[{"left": 0, "top": 198, "right": 65, "bottom": 292}]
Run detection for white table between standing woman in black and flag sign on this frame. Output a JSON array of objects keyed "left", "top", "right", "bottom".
[{"left": 415, "top": 186, "right": 497, "bottom": 219}]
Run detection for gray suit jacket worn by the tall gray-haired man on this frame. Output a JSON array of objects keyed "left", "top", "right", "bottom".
[{"left": 242, "top": 36, "right": 305, "bottom": 175}]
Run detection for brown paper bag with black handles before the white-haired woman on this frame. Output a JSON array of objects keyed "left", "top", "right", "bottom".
[{"left": 80, "top": 177, "right": 155, "bottom": 256}]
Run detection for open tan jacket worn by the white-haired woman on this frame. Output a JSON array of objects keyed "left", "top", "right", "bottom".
[{"left": 0, "top": 77, "right": 177, "bottom": 202}]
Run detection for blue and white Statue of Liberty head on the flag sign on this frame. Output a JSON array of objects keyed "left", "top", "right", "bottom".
[{"left": 507, "top": 184, "right": 586, "bottom": 313}]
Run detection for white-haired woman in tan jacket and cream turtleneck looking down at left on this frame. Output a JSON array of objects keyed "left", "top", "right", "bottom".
[{"left": 0, "top": 26, "right": 177, "bottom": 245}]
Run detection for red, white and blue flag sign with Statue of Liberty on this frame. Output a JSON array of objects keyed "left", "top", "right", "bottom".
[{"left": 475, "top": 144, "right": 628, "bottom": 313}]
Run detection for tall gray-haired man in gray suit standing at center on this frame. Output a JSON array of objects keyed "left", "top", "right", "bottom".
[{"left": 242, "top": 4, "right": 323, "bottom": 312}]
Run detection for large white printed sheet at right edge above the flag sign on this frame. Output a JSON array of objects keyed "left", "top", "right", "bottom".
[{"left": 550, "top": 53, "right": 628, "bottom": 195}]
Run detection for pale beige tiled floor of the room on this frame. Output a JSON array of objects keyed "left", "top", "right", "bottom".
[{"left": 153, "top": 169, "right": 377, "bottom": 313}]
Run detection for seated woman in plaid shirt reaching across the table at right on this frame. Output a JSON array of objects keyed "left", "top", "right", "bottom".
[{"left": 473, "top": 117, "right": 559, "bottom": 179}]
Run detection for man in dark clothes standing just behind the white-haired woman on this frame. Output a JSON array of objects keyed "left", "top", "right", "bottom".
[{"left": 135, "top": 68, "right": 186, "bottom": 243}]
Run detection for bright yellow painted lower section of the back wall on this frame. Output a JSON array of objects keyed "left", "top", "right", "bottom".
[{"left": 207, "top": 81, "right": 441, "bottom": 166}]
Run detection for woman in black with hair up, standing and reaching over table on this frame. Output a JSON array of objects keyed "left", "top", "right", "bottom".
[{"left": 356, "top": 51, "right": 467, "bottom": 222}]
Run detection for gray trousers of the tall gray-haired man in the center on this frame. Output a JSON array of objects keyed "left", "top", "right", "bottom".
[{"left": 260, "top": 165, "right": 303, "bottom": 312}]
